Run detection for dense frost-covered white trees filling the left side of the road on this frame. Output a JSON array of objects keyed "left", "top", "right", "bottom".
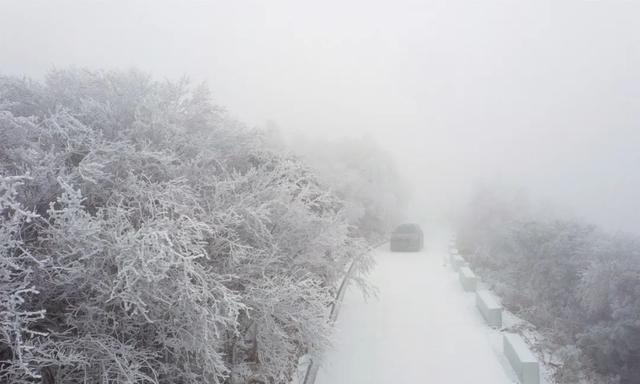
[{"left": 0, "top": 69, "right": 404, "bottom": 384}]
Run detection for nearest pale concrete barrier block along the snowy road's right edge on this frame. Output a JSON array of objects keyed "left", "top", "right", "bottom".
[{"left": 502, "top": 333, "right": 540, "bottom": 384}]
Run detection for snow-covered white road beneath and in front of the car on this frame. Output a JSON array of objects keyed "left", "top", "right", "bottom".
[{"left": 316, "top": 233, "right": 516, "bottom": 384}]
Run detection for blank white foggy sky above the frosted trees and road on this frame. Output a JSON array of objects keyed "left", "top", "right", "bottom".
[{"left": 0, "top": 0, "right": 640, "bottom": 232}]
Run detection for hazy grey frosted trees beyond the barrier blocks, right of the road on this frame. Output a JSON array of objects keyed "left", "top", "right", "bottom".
[{"left": 458, "top": 190, "right": 640, "bottom": 384}]
